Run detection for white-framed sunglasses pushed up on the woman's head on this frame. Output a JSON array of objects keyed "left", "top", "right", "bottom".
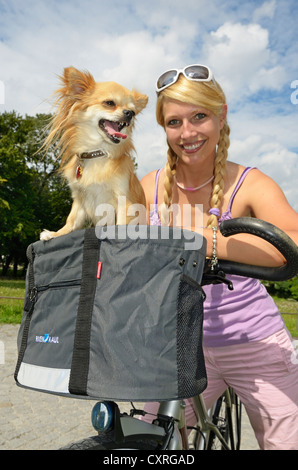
[{"left": 156, "top": 64, "right": 215, "bottom": 93}]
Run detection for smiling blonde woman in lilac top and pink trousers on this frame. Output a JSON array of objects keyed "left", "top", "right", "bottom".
[{"left": 142, "top": 65, "right": 298, "bottom": 450}]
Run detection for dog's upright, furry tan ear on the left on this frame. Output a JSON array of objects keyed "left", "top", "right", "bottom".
[{"left": 61, "top": 67, "right": 95, "bottom": 99}]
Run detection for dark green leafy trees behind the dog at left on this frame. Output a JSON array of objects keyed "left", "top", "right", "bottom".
[{"left": 0, "top": 112, "right": 71, "bottom": 275}]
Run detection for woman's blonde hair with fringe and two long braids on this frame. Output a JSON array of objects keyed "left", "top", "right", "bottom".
[{"left": 156, "top": 74, "right": 230, "bottom": 228}]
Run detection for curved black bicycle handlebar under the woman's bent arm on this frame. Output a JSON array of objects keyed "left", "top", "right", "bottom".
[{"left": 216, "top": 217, "right": 298, "bottom": 281}]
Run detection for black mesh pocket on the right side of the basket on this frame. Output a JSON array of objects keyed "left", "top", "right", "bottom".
[{"left": 177, "top": 274, "right": 207, "bottom": 398}]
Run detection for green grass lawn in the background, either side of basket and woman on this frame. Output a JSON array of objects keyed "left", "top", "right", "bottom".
[{"left": 0, "top": 278, "right": 298, "bottom": 338}]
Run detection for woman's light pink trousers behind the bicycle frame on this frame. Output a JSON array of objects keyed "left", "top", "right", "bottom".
[{"left": 143, "top": 329, "right": 298, "bottom": 450}]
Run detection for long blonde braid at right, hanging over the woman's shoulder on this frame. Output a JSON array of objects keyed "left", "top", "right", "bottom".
[{"left": 207, "top": 122, "right": 230, "bottom": 228}]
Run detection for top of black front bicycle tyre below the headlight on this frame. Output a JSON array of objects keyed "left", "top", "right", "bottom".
[{"left": 60, "top": 434, "right": 160, "bottom": 450}]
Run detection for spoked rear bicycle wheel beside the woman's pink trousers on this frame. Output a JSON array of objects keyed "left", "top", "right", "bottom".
[{"left": 207, "top": 389, "right": 242, "bottom": 450}]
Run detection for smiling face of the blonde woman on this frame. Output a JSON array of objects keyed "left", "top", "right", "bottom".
[{"left": 163, "top": 99, "right": 226, "bottom": 165}]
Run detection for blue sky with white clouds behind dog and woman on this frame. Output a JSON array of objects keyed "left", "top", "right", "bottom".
[{"left": 0, "top": 0, "right": 298, "bottom": 210}]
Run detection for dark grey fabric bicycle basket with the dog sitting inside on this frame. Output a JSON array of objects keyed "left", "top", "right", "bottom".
[{"left": 15, "top": 226, "right": 207, "bottom": 401}]
